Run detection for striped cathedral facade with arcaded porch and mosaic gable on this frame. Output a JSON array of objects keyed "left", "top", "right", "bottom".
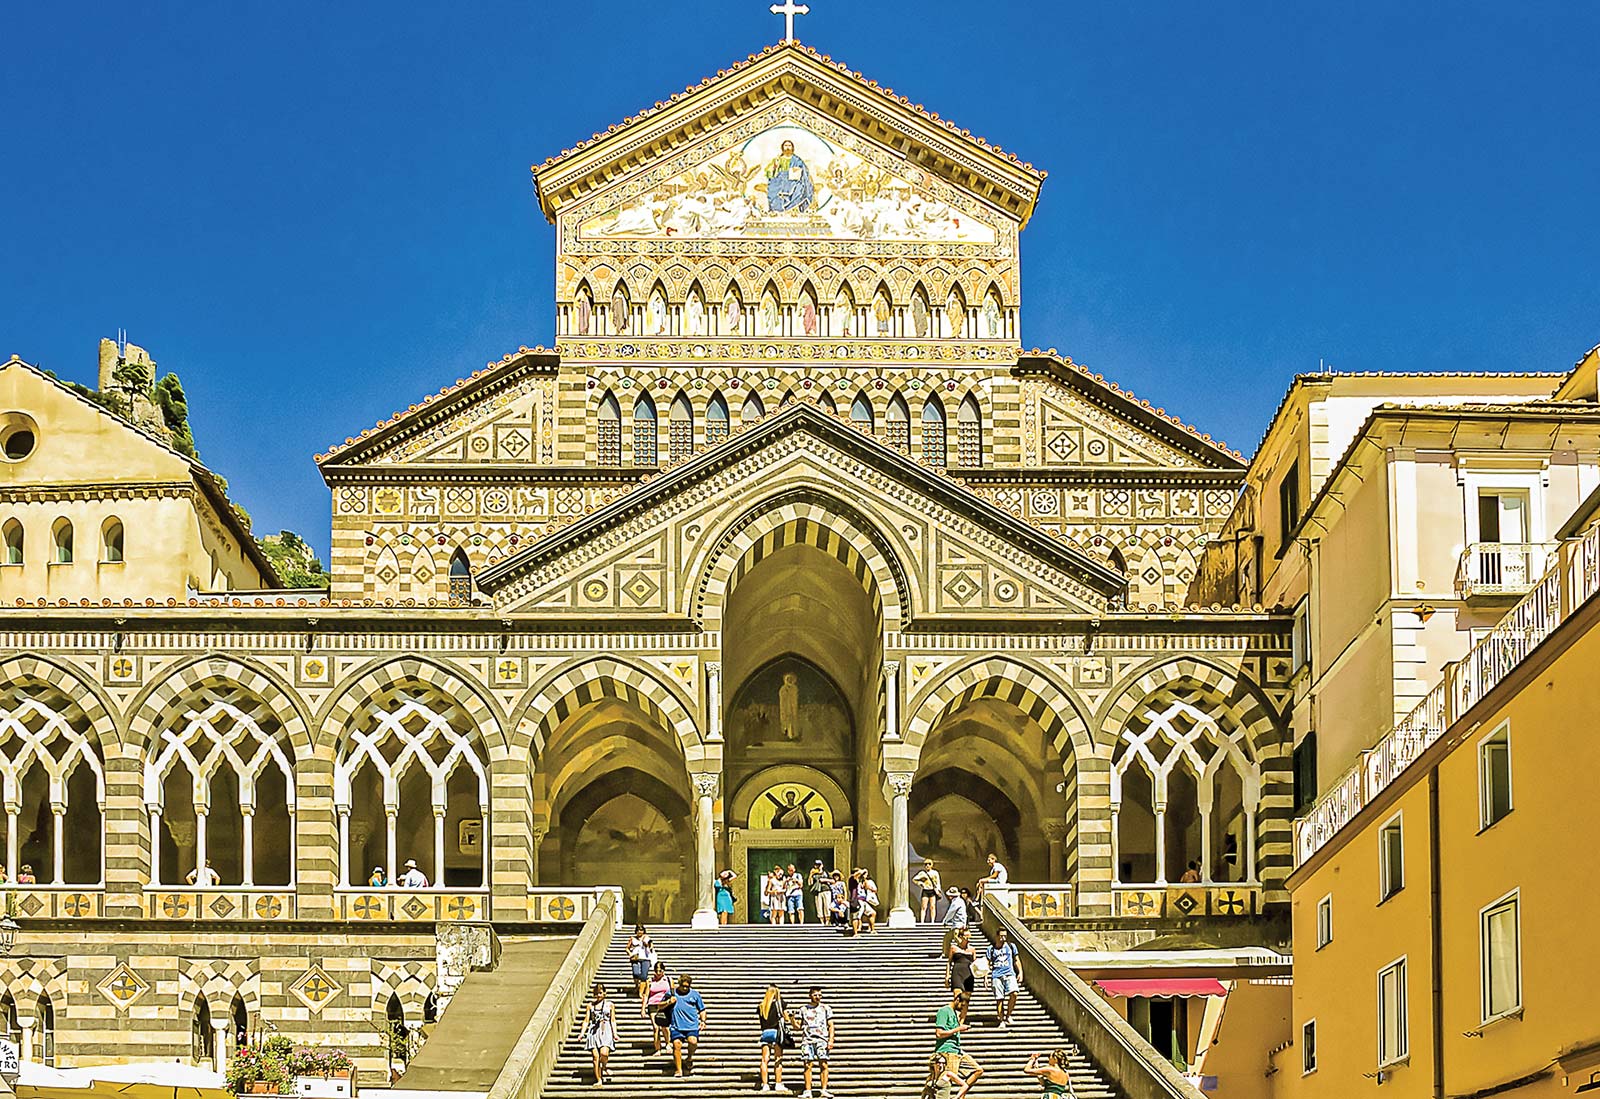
[{"left": 0, "top": 43, "right": 1293, "bottom": 1065}]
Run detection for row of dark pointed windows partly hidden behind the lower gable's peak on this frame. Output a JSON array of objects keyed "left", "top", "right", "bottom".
[{"left": 595, "top": 389, "right": 984, "bottom": 469}]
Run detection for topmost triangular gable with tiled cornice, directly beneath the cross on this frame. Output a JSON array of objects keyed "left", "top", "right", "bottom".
[{"left": 533, "top": 43, "right": 1043, "bottom": 235}]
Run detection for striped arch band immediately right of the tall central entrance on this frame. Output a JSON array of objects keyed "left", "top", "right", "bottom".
[{"left": 904, "top": 656, "right": 1094, "bottom": 760}]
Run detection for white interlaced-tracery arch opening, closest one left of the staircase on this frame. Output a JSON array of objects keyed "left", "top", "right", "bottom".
[{"left": 333, "top": 681, "right": 490, "bottom": 889}]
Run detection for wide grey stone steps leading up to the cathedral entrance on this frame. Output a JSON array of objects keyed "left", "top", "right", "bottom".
[{"left": 544, "top": 925, "right": 1120, "bottom": 1099}]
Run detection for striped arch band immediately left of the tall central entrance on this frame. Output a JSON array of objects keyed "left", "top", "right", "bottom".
[{"left": 514, "top": 656, "right": 701, "bottom": 758}]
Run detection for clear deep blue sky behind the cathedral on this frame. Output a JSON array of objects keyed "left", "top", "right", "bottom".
[{"left": 0, "top": 0, "right": 1600, "bottom": 550}]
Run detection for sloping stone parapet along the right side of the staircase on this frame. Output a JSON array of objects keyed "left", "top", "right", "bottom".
[{"left": 979, "top": 904, "right": 1205, "bottom": 1099}]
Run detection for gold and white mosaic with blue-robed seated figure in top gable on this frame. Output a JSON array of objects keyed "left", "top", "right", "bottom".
[{"left": 582, "top": 125, "right": 995, "bottom": 245}]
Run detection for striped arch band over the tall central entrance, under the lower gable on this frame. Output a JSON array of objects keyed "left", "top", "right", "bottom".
[{"left": 693, "top": 490, "right": 912, "bottom": 630}]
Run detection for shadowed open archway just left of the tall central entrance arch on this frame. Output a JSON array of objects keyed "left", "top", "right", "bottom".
[{"left": 534, "top": 685, "right": 696, "bottom": 923}]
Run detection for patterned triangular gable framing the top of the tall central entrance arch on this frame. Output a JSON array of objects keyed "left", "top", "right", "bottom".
[{"left": 477, "top": 403, "right": 1123, "bottom": 619}]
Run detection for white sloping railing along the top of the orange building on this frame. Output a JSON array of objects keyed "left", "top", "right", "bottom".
[{"left": 1294, "top": 526, "right": 1600, "bottom": 865}]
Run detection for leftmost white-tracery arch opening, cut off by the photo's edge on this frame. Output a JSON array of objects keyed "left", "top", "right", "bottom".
[{"left": 0, "top": 680, "right": 106, "bottom": 885}]
